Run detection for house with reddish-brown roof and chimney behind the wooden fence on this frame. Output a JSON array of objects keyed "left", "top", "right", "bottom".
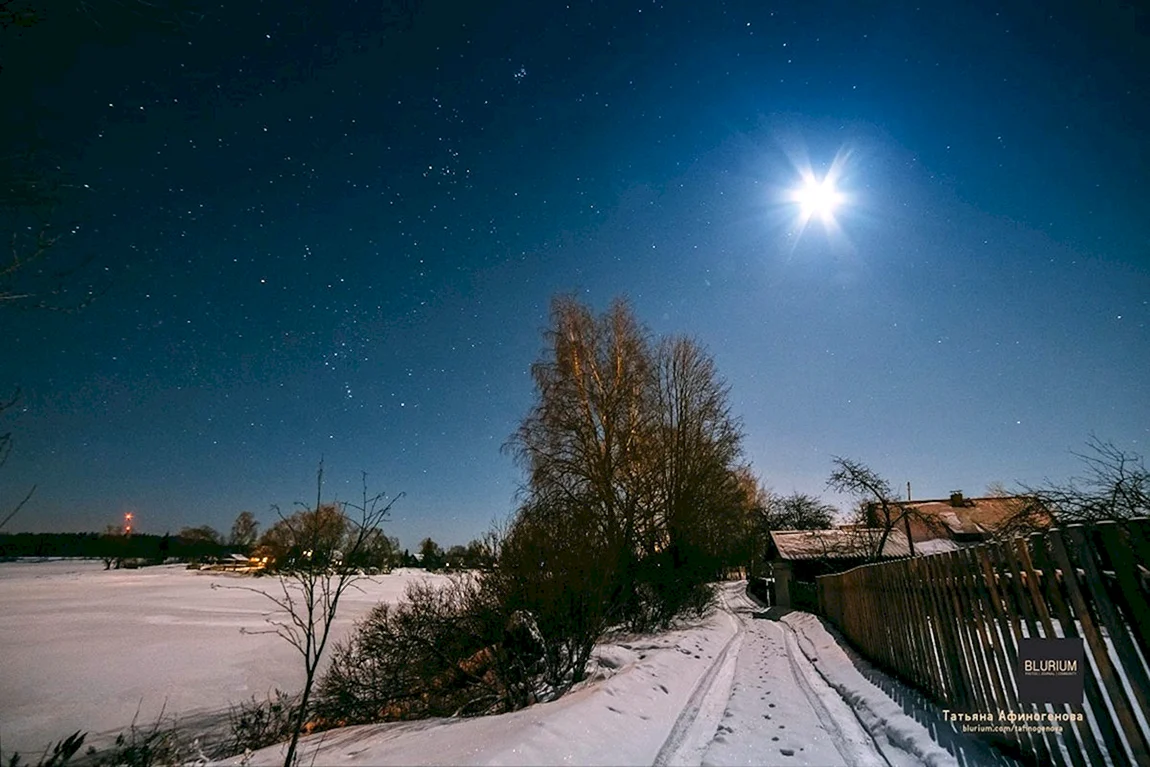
[{"left": 867, "top": 490, "right": 1052, "bottom": 554}]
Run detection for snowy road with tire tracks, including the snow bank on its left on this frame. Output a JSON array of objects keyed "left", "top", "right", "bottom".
[{"left": 221, "top": 583, "right": 1005, "bottom": 767}]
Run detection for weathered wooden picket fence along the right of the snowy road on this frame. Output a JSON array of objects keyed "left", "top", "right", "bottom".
[{"left": 818, "top": 520, "right": 1150, "bottom": 767}]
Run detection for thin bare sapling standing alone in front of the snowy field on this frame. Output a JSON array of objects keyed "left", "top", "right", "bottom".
[{"left": 225, "top": 461, "right": 404, "bottom": 767}]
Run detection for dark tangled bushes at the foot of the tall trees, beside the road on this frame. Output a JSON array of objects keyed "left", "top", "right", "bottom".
[{"left": 309, "top": 499, "right": 713, "bottom": 729}]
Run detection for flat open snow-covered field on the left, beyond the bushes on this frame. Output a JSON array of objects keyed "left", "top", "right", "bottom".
[{"left": 0, "top": 560, "right": 442, "bottom": 756}]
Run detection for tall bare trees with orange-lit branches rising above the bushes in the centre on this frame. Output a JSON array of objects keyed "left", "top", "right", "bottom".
[{"left": 500, "top": 297, "right": 745, "bottom": 628}]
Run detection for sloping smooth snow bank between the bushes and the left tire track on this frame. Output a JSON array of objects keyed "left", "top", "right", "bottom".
[{"left": 223, "top": 613, "right": 736, "bottom": 767}]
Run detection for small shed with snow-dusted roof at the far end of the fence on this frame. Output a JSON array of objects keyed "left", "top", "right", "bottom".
[{"left": 767, "top": 527, "right": 911, "bottom": 607}]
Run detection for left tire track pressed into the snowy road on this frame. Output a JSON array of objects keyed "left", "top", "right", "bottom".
[{"left": 654, "top": 589, "right": 746, "bottom": 767}]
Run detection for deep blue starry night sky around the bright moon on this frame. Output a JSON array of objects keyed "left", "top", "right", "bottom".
[{"left": 0, "top": 0, "right": 1150, "bottom": 547}]
